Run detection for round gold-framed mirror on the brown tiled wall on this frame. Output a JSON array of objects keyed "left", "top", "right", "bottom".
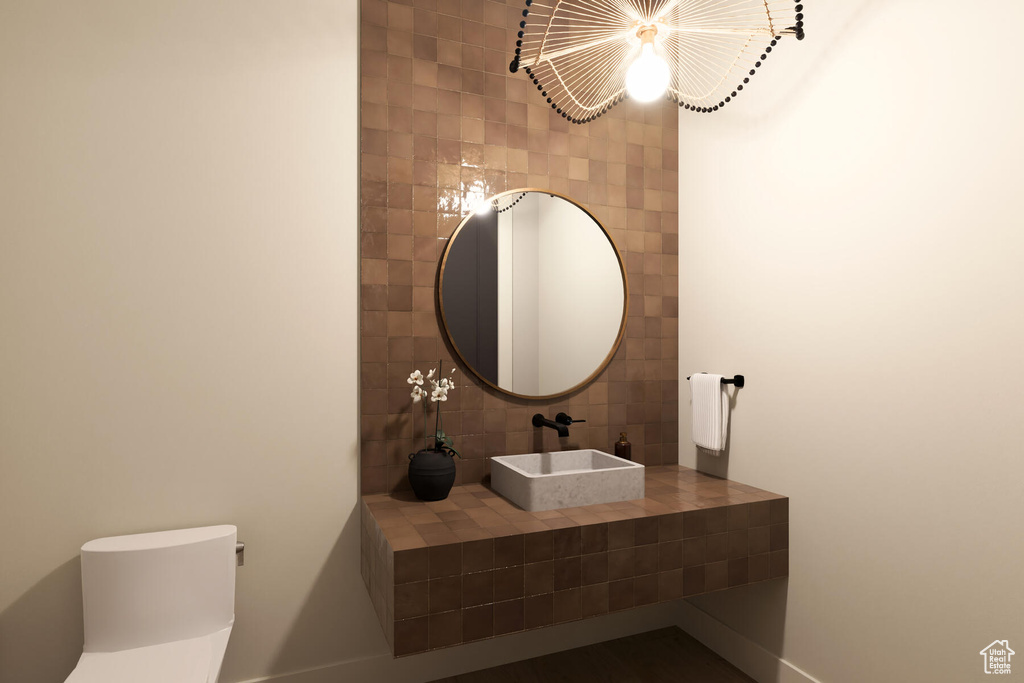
[{"left": 438, "top": 189, "right": 628, "bottom": 398}]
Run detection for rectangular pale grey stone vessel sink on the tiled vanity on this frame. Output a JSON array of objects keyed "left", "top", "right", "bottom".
[{"left": 490, "top": 449, "right": 644, "bottom": 512}]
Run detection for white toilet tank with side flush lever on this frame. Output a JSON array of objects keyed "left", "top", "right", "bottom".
[{"left": 82, "top": 524, "right": 238, "bottom": 652}]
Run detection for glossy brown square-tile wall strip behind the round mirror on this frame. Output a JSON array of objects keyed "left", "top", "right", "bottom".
[{"left": 360, "top": 0, "right": 678, "bottom": 493}]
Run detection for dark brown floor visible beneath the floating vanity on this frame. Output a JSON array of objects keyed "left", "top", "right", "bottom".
[{"left": 434, "top": 628, "right": 756, "bottom": 683}]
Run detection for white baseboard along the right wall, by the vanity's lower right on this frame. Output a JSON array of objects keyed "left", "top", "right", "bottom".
[{"left": 678, "top": 600, "right": 821, "bottom": 683}]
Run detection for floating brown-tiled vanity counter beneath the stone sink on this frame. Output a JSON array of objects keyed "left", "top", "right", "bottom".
[{"left": 361, "top": 465, "right": 790, "bottom": 656}]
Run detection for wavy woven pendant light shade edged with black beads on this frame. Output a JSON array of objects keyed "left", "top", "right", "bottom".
[{"left": 509, "top": 0, "right": 804, "bottom": 124}]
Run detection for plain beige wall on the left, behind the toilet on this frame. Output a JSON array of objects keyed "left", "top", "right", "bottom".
[{"left": 0, "top": 0, "right": 372, "bottom": 683}]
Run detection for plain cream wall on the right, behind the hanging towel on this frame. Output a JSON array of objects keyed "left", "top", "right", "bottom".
[{"left": 679, "top": 0, "right": 1024, "bottom": 683}]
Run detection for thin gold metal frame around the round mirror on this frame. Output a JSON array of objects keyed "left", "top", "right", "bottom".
[{"left": 435, "top": 187, "right": 630, "bottom": 400}]
